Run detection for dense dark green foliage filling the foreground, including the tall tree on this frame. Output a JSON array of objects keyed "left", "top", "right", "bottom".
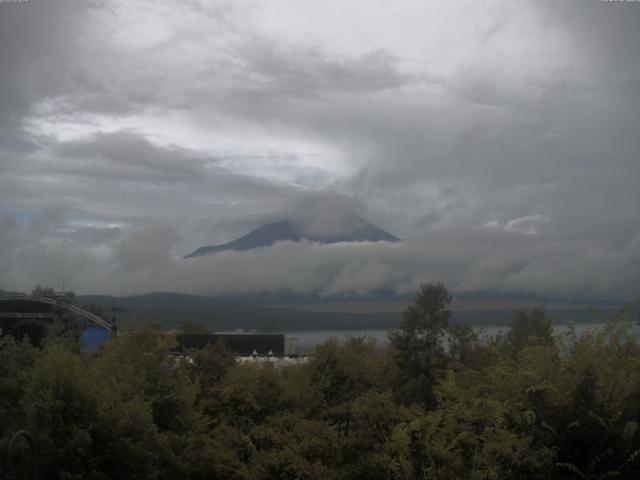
[{"left": 0, "top": 284, "right": 640, "bottom": 480}]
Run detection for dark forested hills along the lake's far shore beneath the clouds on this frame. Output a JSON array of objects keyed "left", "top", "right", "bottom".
[{"left": 77, "top": 292, "right": 621, "bottom": 331}]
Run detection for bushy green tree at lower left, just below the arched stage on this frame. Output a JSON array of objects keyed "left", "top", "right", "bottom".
[{"left": 21, "top": 345, "right": 164, "bottom": 479}]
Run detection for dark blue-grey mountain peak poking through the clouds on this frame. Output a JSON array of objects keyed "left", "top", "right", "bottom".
[{"left": 184, "top": 214, "right": 400, "bottom": 258}]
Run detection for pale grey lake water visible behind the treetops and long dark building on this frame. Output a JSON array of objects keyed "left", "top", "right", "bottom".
[{"left": 280, "top": 323, "right": 640, "bottom": 353}]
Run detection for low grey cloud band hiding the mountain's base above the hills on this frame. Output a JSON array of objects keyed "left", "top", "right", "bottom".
[{"left": 0, "top": 214, "right": 640, "bottom": 299}]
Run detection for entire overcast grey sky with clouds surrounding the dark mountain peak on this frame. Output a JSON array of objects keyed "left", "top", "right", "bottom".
[{"left": 0, "top": 0, "right": 640, "bottom": 299}]
